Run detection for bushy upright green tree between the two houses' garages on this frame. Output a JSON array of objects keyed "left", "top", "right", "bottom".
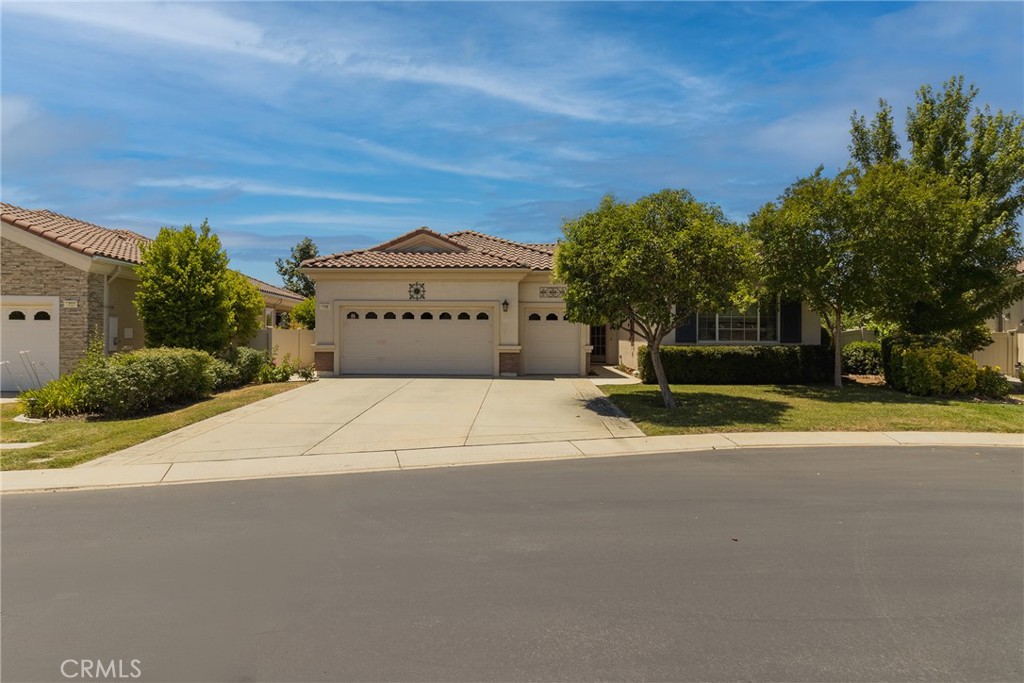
[{"left": 134, "top": 220, "right": 230, "bottom": 352}]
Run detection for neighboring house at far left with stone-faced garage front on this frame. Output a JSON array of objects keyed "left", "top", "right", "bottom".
[{"left": 0, "top": 203, "right": 302, "bottom": 391}]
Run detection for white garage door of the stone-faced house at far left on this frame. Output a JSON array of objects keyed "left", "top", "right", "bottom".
[{"left": 0, "top": 296, "right": 60, "bottom": 391}]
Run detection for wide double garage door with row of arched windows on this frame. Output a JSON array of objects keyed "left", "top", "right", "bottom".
[{"left": 341, "top": 304, "right": 495, "bottom": 377}]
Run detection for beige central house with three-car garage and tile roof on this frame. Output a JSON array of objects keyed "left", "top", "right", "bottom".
[{"left": 302, "top": 227, "right": 820, "bottom": 377}]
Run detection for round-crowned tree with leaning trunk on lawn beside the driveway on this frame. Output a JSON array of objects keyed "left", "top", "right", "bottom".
[{"left": 554, "top": 189, "right": 754, "bottom": 409}]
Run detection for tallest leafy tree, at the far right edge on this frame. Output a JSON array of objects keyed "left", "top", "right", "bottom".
[{"left": 850, "top": 77, "right": 1024, "bottom": 335}]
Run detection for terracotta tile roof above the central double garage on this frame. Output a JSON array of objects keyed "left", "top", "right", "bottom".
[{"left": 302, "top": 227, "right": 553, "bottom": 270}]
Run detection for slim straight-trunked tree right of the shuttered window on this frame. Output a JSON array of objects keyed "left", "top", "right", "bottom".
[{"left": 751, "top": 168, "right": 872, "bottom": 387}]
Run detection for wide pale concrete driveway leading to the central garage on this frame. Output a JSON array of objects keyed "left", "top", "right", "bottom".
[{"left": 82, "top": 377, "right": 642, "bottom": 467}]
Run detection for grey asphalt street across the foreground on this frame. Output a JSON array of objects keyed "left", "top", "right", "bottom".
[{"left": 0, "top": 447, "right": 1024, "bottom": 681}]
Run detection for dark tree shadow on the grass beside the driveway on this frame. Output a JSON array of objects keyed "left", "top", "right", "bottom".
[{"left": 612, "top": 387, "right": 792, "bottom": 428}]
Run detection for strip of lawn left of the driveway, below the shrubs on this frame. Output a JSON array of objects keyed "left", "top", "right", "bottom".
[{"left": 0, "top": 382, "right": 302, "bottom": 470}]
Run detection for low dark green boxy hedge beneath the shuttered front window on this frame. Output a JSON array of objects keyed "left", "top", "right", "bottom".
[{"left": 637, "top": 346, "right": 833, "bottom": 384}]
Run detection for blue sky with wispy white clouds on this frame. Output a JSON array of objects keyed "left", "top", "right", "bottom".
[{"left": 0, "top": 1, "right": 1024, "bottom": 282}]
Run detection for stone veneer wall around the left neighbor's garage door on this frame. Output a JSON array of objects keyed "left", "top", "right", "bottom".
[{"left": 0, "top": 235, "right": 103, "bottom": 375}]
